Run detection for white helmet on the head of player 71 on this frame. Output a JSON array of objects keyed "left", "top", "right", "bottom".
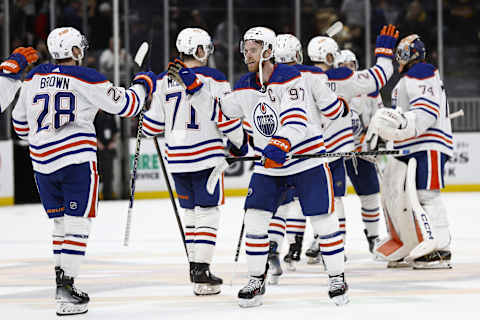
[{"left": 176, "top": 28, "right": 214, "bottom": 62}]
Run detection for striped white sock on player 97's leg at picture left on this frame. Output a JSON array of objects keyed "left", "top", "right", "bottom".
[{"left": 244, "top": 209, "right": 272, "bottom": 277}]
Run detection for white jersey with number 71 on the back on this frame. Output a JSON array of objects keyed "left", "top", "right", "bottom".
[{"left": 143, "top": 67, "right": 243, "bottom": 172}]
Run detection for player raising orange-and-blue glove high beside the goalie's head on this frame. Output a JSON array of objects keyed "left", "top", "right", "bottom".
[{"left": 306, "top": 25, "right": 398, "bottom": 263}]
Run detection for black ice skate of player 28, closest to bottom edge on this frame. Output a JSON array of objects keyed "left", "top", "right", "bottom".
[{"left": 56, "top": 275, "right": 90, "bottom": 316}]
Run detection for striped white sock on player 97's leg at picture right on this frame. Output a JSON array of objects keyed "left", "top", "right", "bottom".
[{"left": 310, "top": 214, "right": 345, "bottom": 275}]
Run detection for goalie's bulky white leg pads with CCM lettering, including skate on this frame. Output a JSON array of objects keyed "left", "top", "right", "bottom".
[{"left": 374, "top": 157, "right": 450, "bottom": 269}]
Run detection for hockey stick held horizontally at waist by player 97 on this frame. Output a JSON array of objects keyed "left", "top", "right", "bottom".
[{"left": 207, "top": 150, "right": 400, "bottom": 194}]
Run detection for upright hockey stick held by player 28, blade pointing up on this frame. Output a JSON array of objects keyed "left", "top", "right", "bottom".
[{"left": 123, "top": 42, "right": 149, "bottom": 247}]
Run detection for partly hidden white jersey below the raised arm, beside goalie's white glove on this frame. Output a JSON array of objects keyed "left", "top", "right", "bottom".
[{"left": 350, "top": 92, "right": 383, "bottom": 152}]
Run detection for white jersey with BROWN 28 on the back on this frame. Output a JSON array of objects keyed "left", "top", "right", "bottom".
[{"left": 12, "top": 64, "right": 146, "bottom": 174}]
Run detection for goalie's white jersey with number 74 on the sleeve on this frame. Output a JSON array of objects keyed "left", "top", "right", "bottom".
[{"left": 392, "top": 63, "right": 453, "bottom": 156}]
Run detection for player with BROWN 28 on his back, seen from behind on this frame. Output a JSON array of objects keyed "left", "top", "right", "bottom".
[{"left": 8, "top": 28, "right": 156, "bottom": 315}]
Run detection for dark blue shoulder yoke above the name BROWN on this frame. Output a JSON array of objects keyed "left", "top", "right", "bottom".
[{"left": 25, "top": 63, "right": 108, "bottom": 84}]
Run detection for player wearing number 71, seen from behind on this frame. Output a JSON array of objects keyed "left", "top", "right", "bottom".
[{"left": 139, "top": 28, "right": 246, "bottom": 295}]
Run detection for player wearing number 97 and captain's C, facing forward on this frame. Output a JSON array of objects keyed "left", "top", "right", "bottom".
[{"left": 172, "top": 27, "right": 348, "bottom": 307}]
